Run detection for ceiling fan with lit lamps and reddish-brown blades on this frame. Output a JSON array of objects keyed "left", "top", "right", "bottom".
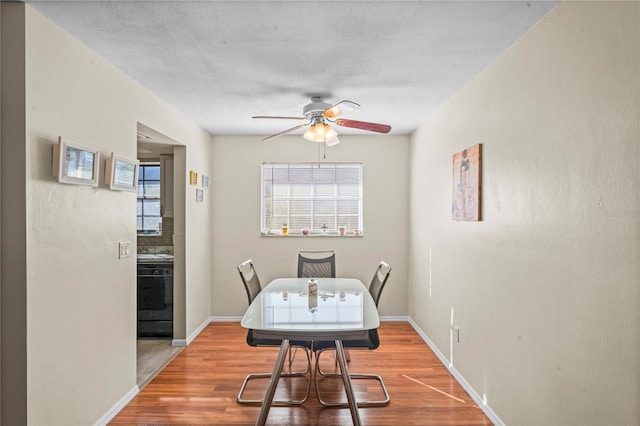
[{"left": 251, "top": 96, "right": 391, "bottom": 146}]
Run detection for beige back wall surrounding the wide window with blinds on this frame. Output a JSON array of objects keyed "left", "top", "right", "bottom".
[{"left": 211, "top": 135, "right": 409, "bottom": 316}]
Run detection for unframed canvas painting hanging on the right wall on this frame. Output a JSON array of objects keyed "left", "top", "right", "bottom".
[{"left": 451, "top": 144, "right": 482, "bottom": 221}]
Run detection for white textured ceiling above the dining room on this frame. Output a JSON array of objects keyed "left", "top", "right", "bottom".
[{"left": 25, "top": 0, "right": 557, "bottom": 136}]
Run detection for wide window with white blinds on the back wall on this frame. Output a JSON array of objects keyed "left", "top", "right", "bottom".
[{"left": 262, "top": 162, "right": 363, "bottom": 235}]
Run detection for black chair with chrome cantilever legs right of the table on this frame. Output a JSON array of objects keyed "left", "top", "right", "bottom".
[{"left": 313, "top": 261, "right": 391, "bottom": 407}]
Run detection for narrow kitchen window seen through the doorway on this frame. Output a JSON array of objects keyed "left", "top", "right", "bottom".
[{"left": 137, "top": 163, "right": 162, "bottom": 235}]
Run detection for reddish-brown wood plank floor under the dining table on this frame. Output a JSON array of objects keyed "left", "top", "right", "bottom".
[{"left": 111, "top": 322, "right": 492, "bottom": 426}]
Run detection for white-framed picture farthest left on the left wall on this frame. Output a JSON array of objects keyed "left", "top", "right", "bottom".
[{"left": 51, "top": 136, "right": 100, "bottom": 186}]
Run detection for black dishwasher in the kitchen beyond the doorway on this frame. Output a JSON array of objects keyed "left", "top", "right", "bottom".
[{"left": 138, "top": 262, "right": 173, "bottom": 339}]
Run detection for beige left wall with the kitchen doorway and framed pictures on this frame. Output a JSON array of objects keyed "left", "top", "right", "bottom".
[{"left": 2, "top": 3, "right": 211, "bottom": 424}]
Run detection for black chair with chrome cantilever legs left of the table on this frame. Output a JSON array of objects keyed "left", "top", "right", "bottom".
[{"left": 236, "top": 259, "right": 312, "bottom": 405}]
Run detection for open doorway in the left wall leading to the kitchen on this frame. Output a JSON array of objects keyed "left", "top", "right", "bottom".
[{"left": 136, "top": 123, "right": 186, "bottom": 389}]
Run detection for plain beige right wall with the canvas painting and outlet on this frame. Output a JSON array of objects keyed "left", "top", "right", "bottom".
[{"left": 409, "top": 1, "right": 640, "bottom": 425}]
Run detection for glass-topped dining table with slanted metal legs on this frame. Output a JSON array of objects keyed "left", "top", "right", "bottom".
[{"left": 241, "top": 278, "right": 380, "bottom": 426}]
